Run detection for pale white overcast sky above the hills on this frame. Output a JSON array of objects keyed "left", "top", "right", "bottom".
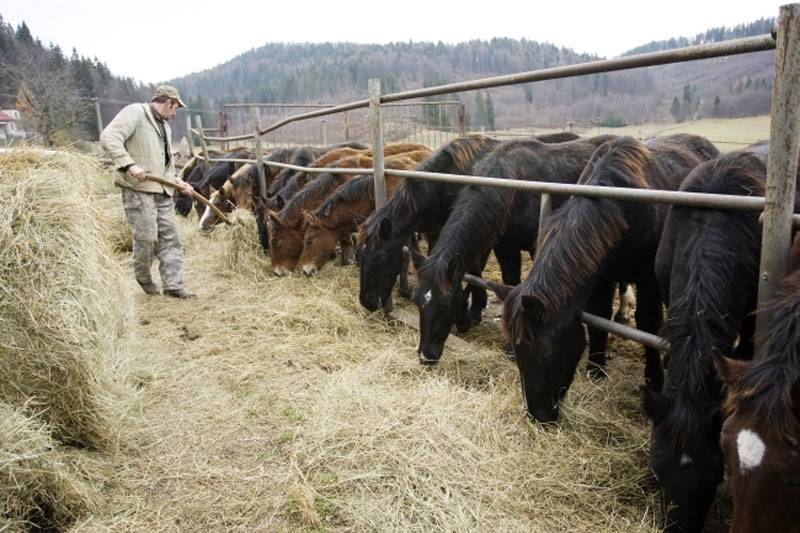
[{"left": 0, "top": 0, "right": 787, "bottom": 83}]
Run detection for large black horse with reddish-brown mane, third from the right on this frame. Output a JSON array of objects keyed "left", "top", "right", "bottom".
[{"left": 503, "top": 135, "right": 717, "bottom": 422}]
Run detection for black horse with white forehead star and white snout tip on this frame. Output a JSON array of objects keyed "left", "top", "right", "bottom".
[{"left": 413, "top": 136, "right": 611, "bottom": 364}]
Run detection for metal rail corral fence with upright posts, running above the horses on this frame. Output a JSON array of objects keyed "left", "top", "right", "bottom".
[{"left": 190, "top": 4, "right": 800, "bottom": 356}]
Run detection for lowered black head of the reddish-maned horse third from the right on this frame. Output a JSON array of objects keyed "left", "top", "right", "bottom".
[{"left": 503, "top": 284, "right": 586, "bottom": 423}]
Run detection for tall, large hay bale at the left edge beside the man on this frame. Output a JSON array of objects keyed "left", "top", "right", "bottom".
[{"left": 0, "top": 150, "right": 132, "bottom": 449}]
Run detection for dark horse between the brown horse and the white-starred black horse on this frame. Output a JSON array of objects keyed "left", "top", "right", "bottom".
[{"left": 357, "top": 133, "right": 577, "bottom": 312}]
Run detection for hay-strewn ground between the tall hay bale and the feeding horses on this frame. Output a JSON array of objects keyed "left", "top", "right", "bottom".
[{"left": 75, "top": 213, "right": 736, "bottom": 532}]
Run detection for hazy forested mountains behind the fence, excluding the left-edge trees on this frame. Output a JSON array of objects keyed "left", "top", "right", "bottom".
[{"left": 173, "top": 15, "right": 774, "bottom": 129}]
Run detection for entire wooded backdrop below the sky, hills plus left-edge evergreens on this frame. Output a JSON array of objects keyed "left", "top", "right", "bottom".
[{"left": 0, "top": 15, "right": 774, "bottom": 142}]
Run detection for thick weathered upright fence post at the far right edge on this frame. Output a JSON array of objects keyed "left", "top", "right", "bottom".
[{"left": 756, "top": 4, "right": 800, "bottom": 339}]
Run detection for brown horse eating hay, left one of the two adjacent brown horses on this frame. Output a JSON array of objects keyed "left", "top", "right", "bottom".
[{"left": 262, "top": 154, "right": 372, "bottom": 276}]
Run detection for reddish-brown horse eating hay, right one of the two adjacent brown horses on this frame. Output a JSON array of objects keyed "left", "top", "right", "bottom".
[{"left": 299, "top": 148, "right": 431, "bottom": 276}]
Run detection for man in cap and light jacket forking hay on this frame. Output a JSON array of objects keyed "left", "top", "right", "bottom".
[{"left": 100, "top": 85, "right": 194, "bottom": 299}]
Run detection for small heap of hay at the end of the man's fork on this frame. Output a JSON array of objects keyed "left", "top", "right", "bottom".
[{"left": 214, "top": 209, "right": 271, "bottom": 278}]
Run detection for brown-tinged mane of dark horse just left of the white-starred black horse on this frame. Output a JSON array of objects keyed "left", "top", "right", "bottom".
[{"left": 358, "top": 135, "right": 497, "bottom": 247}]
